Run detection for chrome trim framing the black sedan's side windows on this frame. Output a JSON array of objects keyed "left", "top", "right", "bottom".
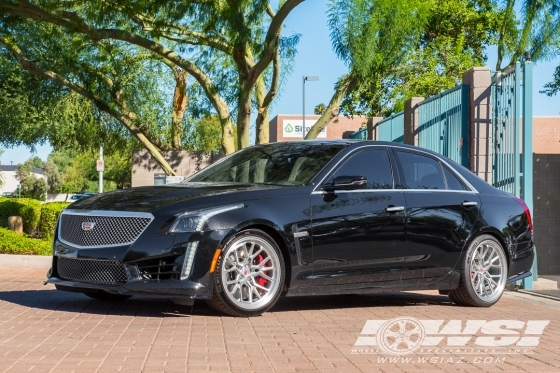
[{"left": 311, "top": 144, "right": 478, "bottom": 194}]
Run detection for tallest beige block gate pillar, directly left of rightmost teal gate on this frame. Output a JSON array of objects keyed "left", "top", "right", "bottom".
[{"left": 463, "top": 67, "right": 493, "bottom": 184}]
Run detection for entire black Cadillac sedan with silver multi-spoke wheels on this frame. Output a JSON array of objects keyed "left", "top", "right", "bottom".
[{"left": 47, "top": 141, "right": 535, "bottom": 316}]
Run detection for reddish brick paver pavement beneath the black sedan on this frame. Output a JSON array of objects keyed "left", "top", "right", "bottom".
[{"left": 0, "top": 268, "right": 560, "bottom": 373}]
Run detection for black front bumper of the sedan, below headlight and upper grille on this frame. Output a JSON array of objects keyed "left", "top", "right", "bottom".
[{"left": 45, "top": 227, "right": 232, "bottom": 299}]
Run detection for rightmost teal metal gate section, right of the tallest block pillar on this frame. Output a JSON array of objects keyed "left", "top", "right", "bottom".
[{"left": 491, "top": 60, "right": 538, "bottom": 289}]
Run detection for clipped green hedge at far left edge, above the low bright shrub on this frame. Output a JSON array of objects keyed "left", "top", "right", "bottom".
[{"left": 0, "top": 198, "right": 41, "bottom": 234}]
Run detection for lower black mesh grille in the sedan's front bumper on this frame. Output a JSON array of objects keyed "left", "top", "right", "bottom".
[{"left": 56, "top": 257, "right": 128, "bottom": 284}]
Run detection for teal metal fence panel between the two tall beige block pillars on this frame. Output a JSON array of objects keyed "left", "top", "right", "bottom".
[{"left": 415, "top": 84, "right": 469, "bottom": 167}]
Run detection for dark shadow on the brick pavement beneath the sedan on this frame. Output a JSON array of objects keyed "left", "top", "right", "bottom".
[{"left": 0, "top": 289, "right": 453, "bottom": 317}]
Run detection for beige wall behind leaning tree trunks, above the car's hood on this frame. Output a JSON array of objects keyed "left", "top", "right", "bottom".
[{"left": 132, "top": 149, "right": 221, "bottom": 187}]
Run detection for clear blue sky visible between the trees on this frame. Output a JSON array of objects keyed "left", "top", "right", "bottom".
[{"left": 0, "top": 0, "right": 560, "bottom": 164}]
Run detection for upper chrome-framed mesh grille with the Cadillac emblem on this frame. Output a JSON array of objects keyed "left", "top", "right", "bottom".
[{"left": 59, "top": 210, "right": 153, "bottom": 247}]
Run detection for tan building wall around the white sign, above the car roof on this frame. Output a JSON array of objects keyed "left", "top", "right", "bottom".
[{"left": 269, "top": 114, "right": 367, "bottom": 142}]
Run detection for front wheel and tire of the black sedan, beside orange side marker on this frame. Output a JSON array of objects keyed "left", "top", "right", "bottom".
[{"left": 208, "top": 229, "right": 286, "bottom": 317}]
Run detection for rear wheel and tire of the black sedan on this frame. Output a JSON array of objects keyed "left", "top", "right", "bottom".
[{"left": 449, "top": 234, "right": 508, "bottom": 307}]
